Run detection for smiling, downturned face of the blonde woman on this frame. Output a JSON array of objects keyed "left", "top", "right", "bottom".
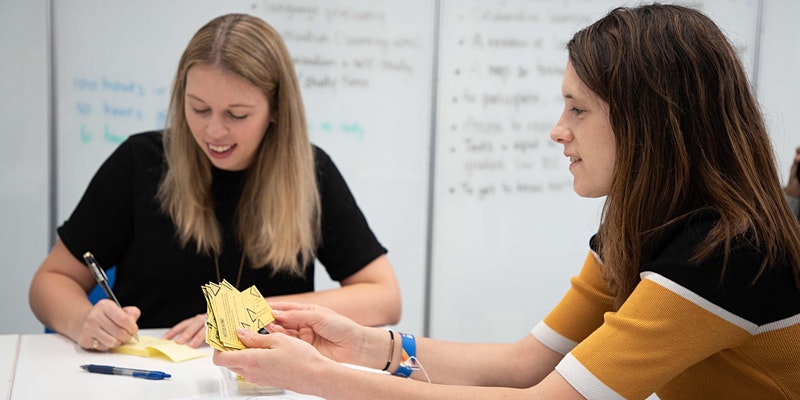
[{"left": 185, "top": 65, "right": 270, "bottom": 171}]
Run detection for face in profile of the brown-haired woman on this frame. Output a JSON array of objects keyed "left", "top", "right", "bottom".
[{"left": 550, "top": 63, "right": 617, "bottom": 197}]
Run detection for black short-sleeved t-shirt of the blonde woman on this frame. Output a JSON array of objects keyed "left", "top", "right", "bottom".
[{"left": 58, "top": 132, "right": 386, "bottom": 329}]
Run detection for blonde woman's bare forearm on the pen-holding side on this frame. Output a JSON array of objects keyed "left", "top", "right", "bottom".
[{"left": 28, "top": 271, "right": 92, "bottom": 341}]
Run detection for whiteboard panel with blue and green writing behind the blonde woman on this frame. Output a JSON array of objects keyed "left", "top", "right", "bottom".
[{"left": 53, "top": 0, "right": 435, "bottom": 332}]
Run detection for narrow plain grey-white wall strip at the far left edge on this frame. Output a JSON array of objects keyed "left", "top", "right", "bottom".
[{"left": 0, "top": 0, "right": 51, "bottom": 333}]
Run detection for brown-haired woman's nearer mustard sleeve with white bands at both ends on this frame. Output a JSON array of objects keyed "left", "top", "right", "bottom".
[{"left": 556, "top": 273, "right": 757, "bottom": 399}]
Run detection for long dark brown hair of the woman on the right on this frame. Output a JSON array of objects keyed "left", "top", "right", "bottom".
[{"left": 567, "top": 4, "right": 800, "bottom": 306}]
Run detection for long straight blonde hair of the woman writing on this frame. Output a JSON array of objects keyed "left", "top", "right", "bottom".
[{"left": 158, "top": 14, "right": 321, "bottom": 275}]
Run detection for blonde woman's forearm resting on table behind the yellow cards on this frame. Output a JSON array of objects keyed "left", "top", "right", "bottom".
[{"left": 267, "top": 283, "right": 402, "bottom": 326}]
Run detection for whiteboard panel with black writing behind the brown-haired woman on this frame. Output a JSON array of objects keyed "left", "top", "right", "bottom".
[{"left": 430, "top": 0, "right": 759, "bottom": 342}]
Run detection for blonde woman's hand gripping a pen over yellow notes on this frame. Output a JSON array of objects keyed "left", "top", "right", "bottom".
[{"left": 76, "top": 299, "right": 141, "bottom": 351}]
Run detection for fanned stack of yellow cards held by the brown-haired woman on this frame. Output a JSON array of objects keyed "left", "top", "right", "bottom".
[{"left": 202, "top": 280, "right": 275, "bottom": 351}]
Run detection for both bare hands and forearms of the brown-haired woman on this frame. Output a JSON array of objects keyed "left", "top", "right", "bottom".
[{"left": 214, "top": 326, "right": 583, "bottom": 400}]
